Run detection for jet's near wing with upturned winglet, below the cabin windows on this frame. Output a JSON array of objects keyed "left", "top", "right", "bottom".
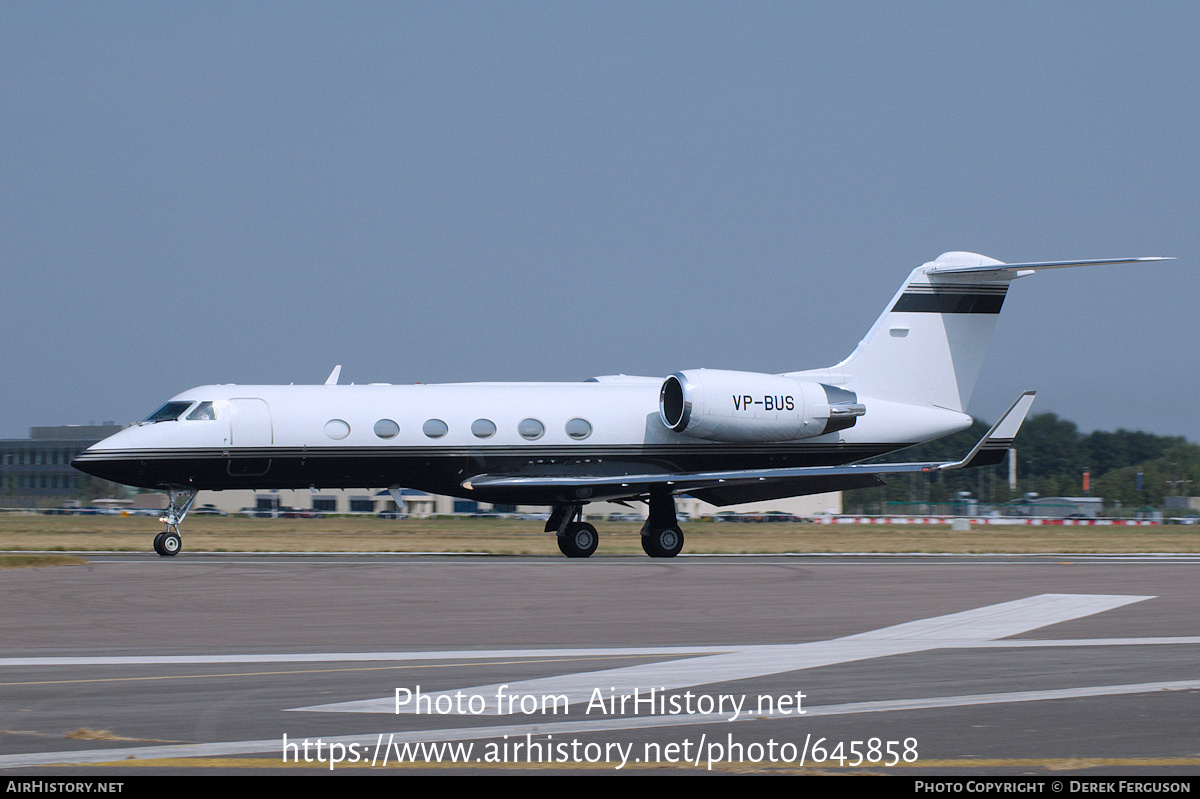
[{"left": 462, "top": 391, "right": 1036, "bottom": 505}]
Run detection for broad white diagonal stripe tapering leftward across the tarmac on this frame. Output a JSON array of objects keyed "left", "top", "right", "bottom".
[{"left": 294, "top": 594, "right": 1152, "bottom": 715}]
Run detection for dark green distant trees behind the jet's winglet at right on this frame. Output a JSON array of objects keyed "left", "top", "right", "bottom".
[{"left": 842, "top": 414, "right": 1200, "bottom": 512}]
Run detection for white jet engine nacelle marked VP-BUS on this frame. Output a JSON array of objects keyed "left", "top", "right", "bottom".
[{"left": 659, "top": 370, "right": 866, "bottom": 441}]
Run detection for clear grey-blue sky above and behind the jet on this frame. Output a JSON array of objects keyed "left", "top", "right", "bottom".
[{"left": 0, "top": 1, "right": 1200, "bottom": 440}]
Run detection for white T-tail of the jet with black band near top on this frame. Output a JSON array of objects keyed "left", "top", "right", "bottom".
[{"left": 790, "top": 252, "right": 1169, "bottom": 413}]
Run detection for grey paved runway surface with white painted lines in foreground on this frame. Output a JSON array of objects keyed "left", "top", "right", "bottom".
[{"left": 0, "top": 554, "right": 1200, "bottom": 775}]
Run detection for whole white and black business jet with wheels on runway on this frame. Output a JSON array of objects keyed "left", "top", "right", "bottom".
[{"left": 73, "top": 252, "right": 1162, "bottom": 558}]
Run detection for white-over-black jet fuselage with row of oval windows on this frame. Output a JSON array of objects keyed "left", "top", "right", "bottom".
[{"left": 76, "top": 378, "right": 971, "bottom": 505}]
